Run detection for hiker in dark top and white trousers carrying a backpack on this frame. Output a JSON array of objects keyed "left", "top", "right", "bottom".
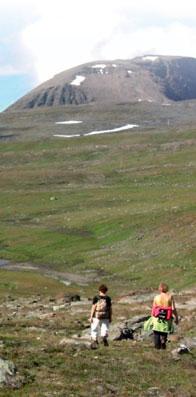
[{"left": 90, "top": 284, "right": 112, "bottom": 349}]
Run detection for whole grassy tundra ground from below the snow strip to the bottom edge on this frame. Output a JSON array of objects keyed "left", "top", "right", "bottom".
[{"left": 0, "top": 106, "right": 196, "bottom": 397}]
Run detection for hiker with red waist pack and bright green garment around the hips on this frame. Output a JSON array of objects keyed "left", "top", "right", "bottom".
[{"left": 151, "top": 283, "right": 178, "bottom": 349}]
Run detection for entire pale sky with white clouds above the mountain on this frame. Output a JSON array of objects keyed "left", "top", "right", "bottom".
[{"left": 0, "top": 0, "right": 196, "bottom": 111}]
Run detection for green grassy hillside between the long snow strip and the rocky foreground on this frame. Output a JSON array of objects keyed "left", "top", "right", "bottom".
[{"left": 0, "top": 130, "right": 196, "bottom": 288}]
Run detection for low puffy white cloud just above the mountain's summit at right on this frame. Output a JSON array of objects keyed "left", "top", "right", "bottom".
[{"left": 99, "top": 23, "right": 196, "bottom": 58}]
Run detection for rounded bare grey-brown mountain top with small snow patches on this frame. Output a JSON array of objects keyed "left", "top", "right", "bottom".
[{"left": 7, "top": 55, "right": 196, "bottom": 111}]
